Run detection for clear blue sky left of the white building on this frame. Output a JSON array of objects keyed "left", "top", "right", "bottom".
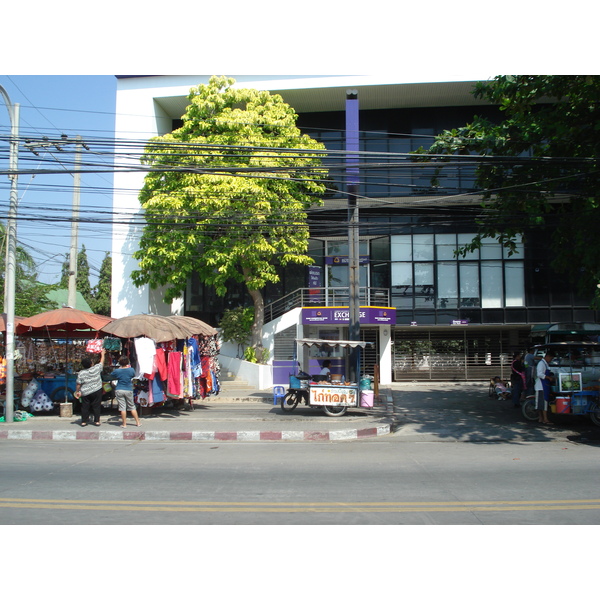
[{"left": 0, "top": 74, "right": 116, "bottom": 285}]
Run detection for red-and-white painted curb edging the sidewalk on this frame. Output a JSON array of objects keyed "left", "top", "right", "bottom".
[{"left": 0, "top": 425, "right": 391, "bottom": 442}]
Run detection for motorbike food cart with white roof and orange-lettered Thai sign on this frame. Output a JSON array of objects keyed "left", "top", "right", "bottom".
[{"left": 281, "top": 338, "right": 373, "bottom": 417}]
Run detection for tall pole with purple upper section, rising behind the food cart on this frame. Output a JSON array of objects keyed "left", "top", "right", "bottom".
[{"left": 346, "top": 90, "right": 360, "bottom": 381}]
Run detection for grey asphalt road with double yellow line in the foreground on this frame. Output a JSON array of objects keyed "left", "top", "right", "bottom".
[{"left": 0, "top": 436, "right": 600, "bottom": 525}]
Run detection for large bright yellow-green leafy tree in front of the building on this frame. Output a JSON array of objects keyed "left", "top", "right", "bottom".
[{"left": 132, "top": 77, "right": 327, "bottom": 347}]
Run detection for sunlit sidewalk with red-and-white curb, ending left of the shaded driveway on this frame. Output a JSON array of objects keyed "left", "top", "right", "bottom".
[{"left": 0, "top": 392, "right": 393, "bottom": 442}]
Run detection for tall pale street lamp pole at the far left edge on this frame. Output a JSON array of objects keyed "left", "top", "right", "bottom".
[{"left": 0, "top": 85, "right": 19, "bottom": 423}]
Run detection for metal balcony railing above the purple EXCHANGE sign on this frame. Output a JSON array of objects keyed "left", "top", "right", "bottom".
[{"left": 265, "top": 287, "right": 390, "bottom": 323}]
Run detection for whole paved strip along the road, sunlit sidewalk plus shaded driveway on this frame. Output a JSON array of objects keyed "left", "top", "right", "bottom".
[{"left": 0, "top": 381, "right": 600, "bottom": 445}]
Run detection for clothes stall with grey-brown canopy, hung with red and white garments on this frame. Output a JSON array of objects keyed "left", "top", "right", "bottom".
[{"left": 102, "top": 315, "right": 220, "bottom": 414}]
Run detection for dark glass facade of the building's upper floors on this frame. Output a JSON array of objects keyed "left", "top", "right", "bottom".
[{"left": 185, "top": 107, "right": 597, "bottom": 329}]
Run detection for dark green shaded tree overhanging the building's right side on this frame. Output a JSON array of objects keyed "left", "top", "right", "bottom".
[{"left": 421, "top": 76, "right": 600, "bottom": 300}]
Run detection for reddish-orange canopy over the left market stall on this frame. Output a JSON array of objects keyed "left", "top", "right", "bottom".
[{"left": 15, "top": 307, "right": 113, "bottom": 337}]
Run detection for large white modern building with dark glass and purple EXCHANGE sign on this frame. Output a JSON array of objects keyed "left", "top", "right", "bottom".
[{"left": 112, "top": 75, "right": 597, "bottom": 383}]
